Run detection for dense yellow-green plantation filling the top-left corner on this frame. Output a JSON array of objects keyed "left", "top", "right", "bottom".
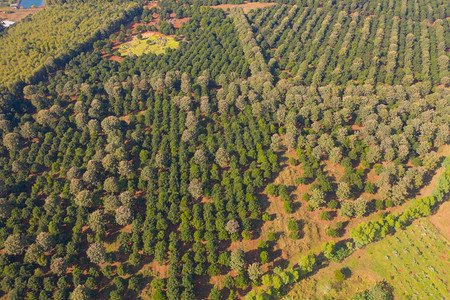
[{"left": 0, "top": 1, "right": 137, "bottom": 86}]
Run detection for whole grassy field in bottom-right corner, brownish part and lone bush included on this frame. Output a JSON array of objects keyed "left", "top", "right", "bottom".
[{"left": 289, "top": 219, "right": 450, "bottom": 299}]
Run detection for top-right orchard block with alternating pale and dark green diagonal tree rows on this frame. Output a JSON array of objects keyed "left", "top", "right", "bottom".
[{"left": 249, "top": 1, "right": 448, "bottom": 85}]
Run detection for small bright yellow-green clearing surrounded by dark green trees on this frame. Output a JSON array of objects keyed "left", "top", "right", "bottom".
[{"left": 119, "top": 35, "right": 179, "bottom": 56}]
